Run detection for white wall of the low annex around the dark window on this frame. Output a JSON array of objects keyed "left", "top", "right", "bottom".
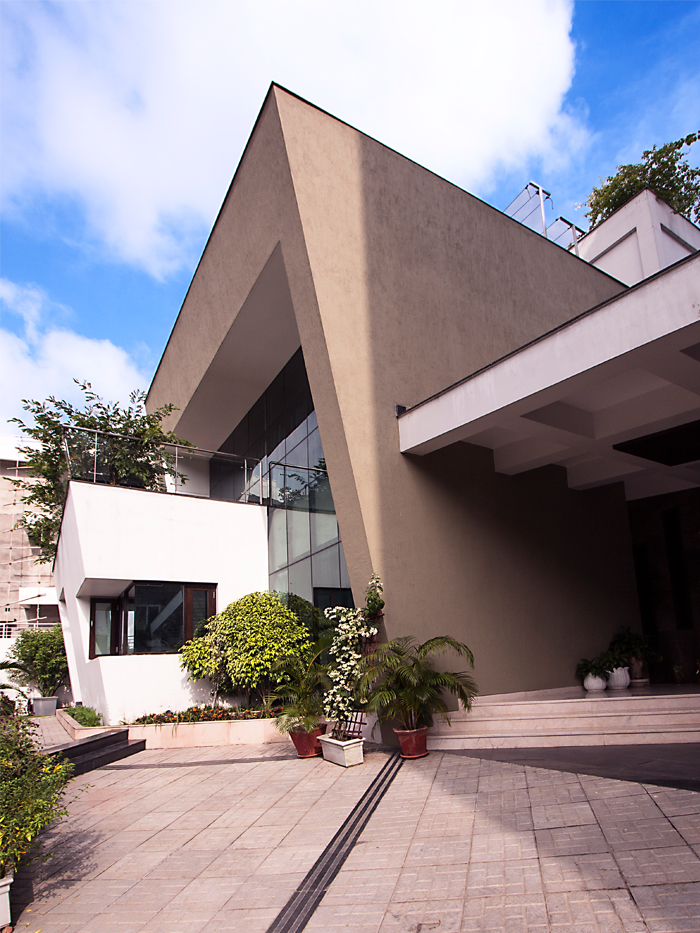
[{"left": 54, "top": 482, "right": 268, "bottom": 725}]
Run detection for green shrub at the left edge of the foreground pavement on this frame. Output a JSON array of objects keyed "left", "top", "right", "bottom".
[{"left": 0, "top": 716, "right": 73, "bottom": 877}]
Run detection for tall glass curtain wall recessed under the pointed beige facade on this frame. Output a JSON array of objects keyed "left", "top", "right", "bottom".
[{"left": 220, "top": 349, "right": 352, "bottom": 609}]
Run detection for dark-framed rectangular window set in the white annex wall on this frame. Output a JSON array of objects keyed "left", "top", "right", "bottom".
[{"left": 90, "top": 581, "right": 216, "bottom": 658}]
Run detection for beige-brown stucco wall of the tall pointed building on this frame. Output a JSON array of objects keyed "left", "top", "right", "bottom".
[{"left": 149, "top": 89, "right": 636, "bottom": 692}]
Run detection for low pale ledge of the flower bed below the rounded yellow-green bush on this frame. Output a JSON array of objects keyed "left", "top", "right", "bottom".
[{"left": 129, "top": 719, "right": 291, "bottom": 749}]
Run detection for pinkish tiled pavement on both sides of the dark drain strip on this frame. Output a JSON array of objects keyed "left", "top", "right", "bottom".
[{"left": 13, "top": 746, "right": 700, "bottom": 933}]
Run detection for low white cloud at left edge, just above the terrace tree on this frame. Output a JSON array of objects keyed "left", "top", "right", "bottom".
[{"left": 0, "top": 279, "right": 147, "bottom": 434}]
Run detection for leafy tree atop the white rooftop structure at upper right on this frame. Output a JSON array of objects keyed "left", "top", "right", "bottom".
[{"left": 584, "top": 133, "right": 700, "bottom": 228}]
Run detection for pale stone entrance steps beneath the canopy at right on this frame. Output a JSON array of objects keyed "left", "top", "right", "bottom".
[{"left": 428, "top": 686, "right": 700, "bottom": 750}]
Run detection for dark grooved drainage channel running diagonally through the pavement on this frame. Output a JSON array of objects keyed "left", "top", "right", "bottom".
[{"left": 267, "top": 752, "right": 403, "bottom": 933}]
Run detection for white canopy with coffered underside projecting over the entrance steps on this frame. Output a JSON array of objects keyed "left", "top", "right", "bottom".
[{"left": 399, "top": 255, "right": 700, "bottom": 499}]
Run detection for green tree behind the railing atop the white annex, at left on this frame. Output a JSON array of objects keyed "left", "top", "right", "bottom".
[{"left": 10, "top": 380, "right": 192, "bottom": 563}]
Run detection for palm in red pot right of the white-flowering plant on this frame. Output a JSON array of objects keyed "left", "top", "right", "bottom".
[{"left": 358, "top": 635, "right": 477, "bottom": 758}]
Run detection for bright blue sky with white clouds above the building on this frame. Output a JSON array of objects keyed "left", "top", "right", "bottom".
[{"left": 0, "top": 0, "right": 700, "bottom": 433}]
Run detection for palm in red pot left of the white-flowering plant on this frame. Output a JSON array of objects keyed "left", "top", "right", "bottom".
[{"left": 273, "top": 641, "right": 330, "bottom": 758}]
